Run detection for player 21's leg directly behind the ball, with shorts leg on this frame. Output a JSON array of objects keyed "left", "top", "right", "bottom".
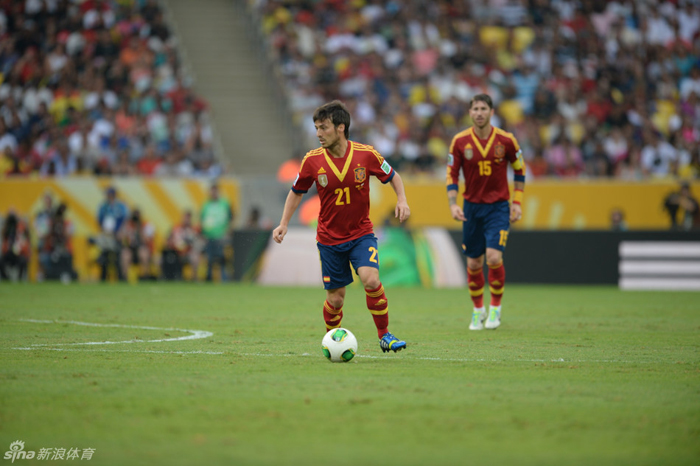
[{"left": 316, "top": 243, "right": 353, "bottom": 331}]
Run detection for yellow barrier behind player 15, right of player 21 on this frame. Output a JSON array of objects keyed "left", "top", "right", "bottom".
[{"left": 370, "top": 178, "right": 700, "bottom": 230}]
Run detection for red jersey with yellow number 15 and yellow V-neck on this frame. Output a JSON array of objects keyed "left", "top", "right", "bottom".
[{"left": 447, "top": 126, "right": 525, "bottom": 204}]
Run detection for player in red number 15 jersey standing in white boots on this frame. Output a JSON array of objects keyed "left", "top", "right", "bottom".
[{"left": 447, "top": 94, "right": 525, "bottom": 330}]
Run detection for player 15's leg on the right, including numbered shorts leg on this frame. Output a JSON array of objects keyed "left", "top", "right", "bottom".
[{"left": 485, "top": 202, "right": 510, "bottom": 330}]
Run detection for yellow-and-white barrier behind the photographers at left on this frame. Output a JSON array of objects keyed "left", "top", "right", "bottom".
[{"left": 0, "top": 177, "right": 240, "bottom": 279}]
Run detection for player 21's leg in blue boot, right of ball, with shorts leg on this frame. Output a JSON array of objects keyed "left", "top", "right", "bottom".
[{"left": 350, "top": 235, "right": 406, "bottom": 352}]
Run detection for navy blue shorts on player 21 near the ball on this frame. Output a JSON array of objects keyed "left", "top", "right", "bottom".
[{"left": 316, "top": 233, "right": 379, "bottom": 290}]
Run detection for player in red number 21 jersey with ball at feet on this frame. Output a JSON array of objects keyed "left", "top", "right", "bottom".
[{"left": 272, "top": 100, "right": 411, "bottom": 352}]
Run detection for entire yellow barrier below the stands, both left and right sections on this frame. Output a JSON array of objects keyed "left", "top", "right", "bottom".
[{"left": 0, "top": 177, "right": 700, "bottom": 279}]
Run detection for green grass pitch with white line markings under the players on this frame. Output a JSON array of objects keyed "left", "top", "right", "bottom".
[{"left": 0, "top": 283, "right": 700, "bottom": 466}]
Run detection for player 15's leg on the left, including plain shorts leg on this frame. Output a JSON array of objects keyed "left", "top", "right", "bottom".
[{"left": 462, "top": 201, "right": 486, "bottom": 330}]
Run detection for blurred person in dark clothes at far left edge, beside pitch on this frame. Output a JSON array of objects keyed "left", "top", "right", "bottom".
[{"left": 0, "top": 211, "right": 31, "bottom": 281}]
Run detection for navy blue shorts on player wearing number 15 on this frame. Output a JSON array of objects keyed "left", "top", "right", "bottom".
[{"left": 462, "top": 201, "right": 510, "bottom": 258}]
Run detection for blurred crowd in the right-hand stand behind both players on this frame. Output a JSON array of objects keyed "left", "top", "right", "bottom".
[{"left": 250, "top": 0, "right": 700, "bottom": 180}]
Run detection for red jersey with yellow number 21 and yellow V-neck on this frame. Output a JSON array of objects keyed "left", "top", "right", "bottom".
[{"left": 292, "top": 141, "right": 394, "bottom": 246}]
